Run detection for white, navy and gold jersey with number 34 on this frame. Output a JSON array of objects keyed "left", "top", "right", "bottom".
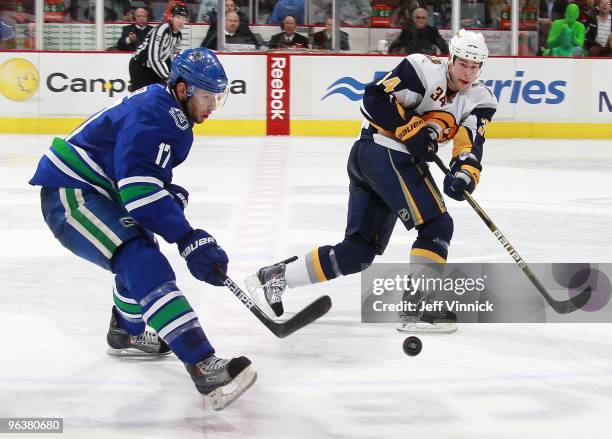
[{"left": 361, "top": 54, "right": 497, "bottom": 161}]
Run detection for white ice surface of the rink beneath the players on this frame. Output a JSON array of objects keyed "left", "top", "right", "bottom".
[{"left": 0, "top": 136, "right": 612, "bottom": 439}]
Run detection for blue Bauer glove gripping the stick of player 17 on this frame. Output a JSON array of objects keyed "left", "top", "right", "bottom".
[{"left": 176, "top": 229, "right": 229, "bottom": 287}]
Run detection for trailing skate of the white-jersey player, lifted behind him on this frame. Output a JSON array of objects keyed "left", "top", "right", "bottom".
[{"left": 244, "top": 262, "right": 287, "bottom": 319}]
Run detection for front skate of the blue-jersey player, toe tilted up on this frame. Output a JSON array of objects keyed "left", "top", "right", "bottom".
[{"left": 185, "top": 355, "right": 257, "bottom": 410}]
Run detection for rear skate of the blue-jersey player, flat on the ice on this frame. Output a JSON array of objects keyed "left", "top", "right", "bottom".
[{"left": 106, "top": 307, "right": 172, "bottom": 357}]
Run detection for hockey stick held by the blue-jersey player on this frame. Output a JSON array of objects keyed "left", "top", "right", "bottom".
[{"left": 215, "top": 268, "right": 331, "bottom": 338}]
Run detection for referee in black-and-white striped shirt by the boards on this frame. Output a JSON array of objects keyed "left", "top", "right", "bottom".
[{"left": 130, "top": 4, "right": 189, "bottom": 91}]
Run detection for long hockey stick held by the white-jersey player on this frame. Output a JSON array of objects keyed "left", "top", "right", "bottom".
[{"left": 431, "top": 153, "right": 591, "bottom": 314}]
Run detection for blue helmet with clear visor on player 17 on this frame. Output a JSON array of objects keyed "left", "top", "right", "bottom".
[{"left": 168, "top": 47, "right": 227, "bottom": 106}]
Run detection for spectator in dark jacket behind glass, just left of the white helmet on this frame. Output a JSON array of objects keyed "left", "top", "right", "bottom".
[{"left": 389, "top": 8, "right": 448, "bottom": 55}]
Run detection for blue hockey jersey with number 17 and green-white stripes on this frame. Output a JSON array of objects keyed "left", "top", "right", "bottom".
[{"left": 30, "top": 84, "right": 193, "bottom": 242}]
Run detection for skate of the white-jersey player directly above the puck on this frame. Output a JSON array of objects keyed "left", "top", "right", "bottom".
[{"left": 396, "top": 290, "right": 457, "bottom": 334}]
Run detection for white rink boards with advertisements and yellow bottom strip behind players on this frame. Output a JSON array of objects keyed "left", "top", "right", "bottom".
[{"left": 0, "top": 52, "right": 612, "bottom": 138}]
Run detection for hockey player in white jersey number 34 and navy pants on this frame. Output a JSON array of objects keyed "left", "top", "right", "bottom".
[{"left": 246, "top": 30, "right": 497, "bottom": 334}]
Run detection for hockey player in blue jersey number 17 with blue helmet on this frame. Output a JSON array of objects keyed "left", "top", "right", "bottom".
[{"left": 30, "top": 48, "right": 257, "bottom": 409}]
